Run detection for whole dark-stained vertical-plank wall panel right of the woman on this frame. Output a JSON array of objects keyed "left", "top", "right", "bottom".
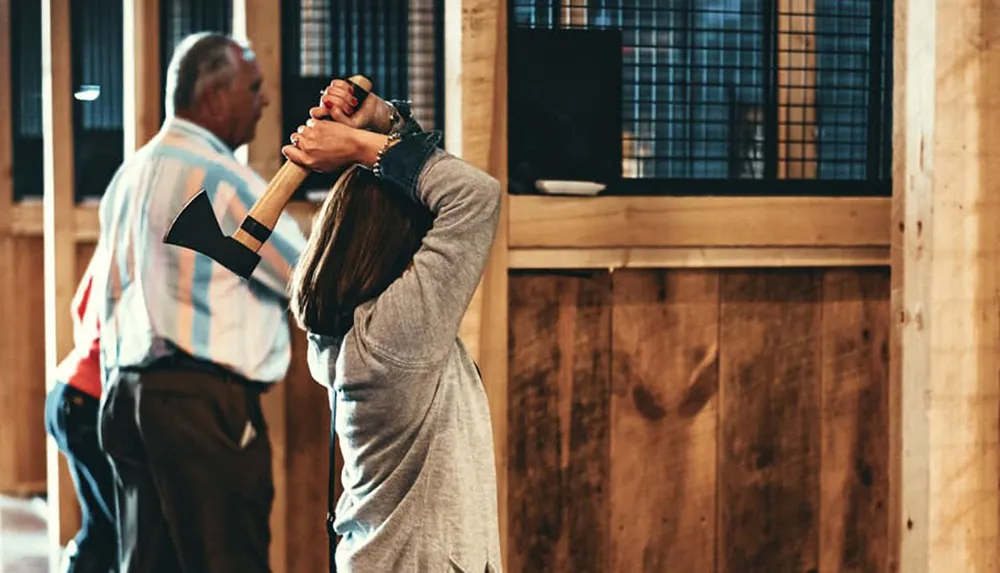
[{"left": 507, "top": 268, "right": 889, "bottom": 573}]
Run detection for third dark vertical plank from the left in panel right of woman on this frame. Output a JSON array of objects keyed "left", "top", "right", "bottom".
[{"left": 718, "top": 270, "right": 821, "bottom": 573}]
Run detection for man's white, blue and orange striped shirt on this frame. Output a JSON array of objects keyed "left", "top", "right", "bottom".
[{"left": 99, "top": 117, "right": 306, "bottom": 382}]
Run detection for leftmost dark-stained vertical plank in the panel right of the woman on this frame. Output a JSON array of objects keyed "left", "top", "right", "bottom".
[{"left": 505, "top": 273, "right": 611, "bottom": 573}]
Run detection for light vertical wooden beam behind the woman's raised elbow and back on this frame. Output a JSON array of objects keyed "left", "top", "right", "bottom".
[{"left": 445, "top": 0, "right": 508, "bottom": 561}]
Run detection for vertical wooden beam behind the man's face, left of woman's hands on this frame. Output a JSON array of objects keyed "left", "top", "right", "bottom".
[{"left": 232, "top": 0, "right": 286, "bottom": 573}]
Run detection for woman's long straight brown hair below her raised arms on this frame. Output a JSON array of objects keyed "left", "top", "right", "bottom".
[{"left": 291, "top": 165, "right": 433, "bottom": 336}]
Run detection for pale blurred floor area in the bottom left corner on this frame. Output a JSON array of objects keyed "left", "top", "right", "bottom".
[{"left": 0, "top": 495, "right": 49, "bottom": 573}]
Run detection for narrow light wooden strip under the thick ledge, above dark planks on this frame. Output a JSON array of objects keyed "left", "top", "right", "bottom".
[{"left": 508, "top": 246, "right": 889, "bottom": 269}]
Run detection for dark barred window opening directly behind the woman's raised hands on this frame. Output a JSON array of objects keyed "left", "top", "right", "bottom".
[{"left": 278, "top": 0, "right": 444, "bottom": 199}]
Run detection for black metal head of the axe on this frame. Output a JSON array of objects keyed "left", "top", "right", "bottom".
[{"left": 163, "top": 189, "right": 260, "bottom": 279}]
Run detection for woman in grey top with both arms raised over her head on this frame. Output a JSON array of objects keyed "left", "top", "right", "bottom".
[{"left": 283, "top": 81, "right": 501, "bottom": 573}]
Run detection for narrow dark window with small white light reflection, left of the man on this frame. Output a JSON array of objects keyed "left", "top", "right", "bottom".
[{"left": 70, "top": 0, "right": 124, "bottom": 199}]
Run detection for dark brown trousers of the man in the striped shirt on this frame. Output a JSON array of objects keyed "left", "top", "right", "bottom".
[{"left": 100, "top": 362, "right": 274, "bottom": 573}]
